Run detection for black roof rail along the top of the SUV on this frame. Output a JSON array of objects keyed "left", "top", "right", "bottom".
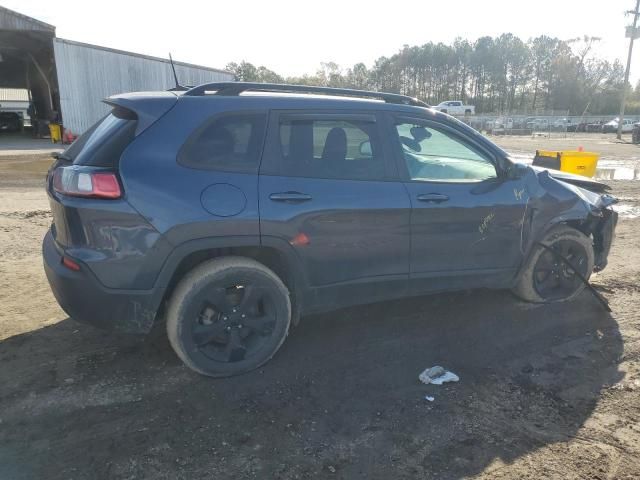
[{"left": 184, "top": 82, "right": 429, "bottom": 107}]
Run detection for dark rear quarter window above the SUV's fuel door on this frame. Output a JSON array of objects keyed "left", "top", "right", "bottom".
[{"left": 178, "top": 113, "right": 266, "bottom": 173}]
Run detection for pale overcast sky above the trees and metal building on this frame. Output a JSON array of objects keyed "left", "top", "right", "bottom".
[{"left": 6, "top": 0, "right": 640, "bottom": 82}]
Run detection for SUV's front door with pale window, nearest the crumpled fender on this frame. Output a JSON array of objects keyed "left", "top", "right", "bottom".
[{"left": 391, "top": 116, "right": 528, "bottom": 288}]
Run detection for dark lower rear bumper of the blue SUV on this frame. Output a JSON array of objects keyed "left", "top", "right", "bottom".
[{"left": 42, "top": 232, "right": 159, "bottom": 333}]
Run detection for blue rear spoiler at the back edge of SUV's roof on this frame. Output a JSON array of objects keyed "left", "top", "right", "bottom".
[{"left": 103, "top": 92, "right": 178, "bottom": 136}]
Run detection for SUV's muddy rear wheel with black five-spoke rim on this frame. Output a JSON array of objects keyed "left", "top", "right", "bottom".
[{"left": 167, "top": 257, "right": 291, "bottom": 377}]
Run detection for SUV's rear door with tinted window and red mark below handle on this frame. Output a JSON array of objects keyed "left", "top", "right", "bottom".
[{"left": 259, "top": 111, "right": 411, "bottom": 306}]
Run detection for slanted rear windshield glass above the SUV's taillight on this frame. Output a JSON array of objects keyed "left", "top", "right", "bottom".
[{"left": 64, "top": 107, "right": 138, "bottom": 168}]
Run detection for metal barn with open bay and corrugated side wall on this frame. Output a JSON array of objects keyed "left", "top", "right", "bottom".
[{"left": 0, "top": 7, "right": 234, "bottom": 135}]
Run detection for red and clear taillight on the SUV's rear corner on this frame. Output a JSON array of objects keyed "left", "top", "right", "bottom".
[{"left": 53, "top": 166, "right": 122, "bottom": 199}]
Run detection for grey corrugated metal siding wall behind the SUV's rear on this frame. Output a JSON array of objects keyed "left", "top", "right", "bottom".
[{"left": 53, "top": 38, "right": 233, "bottom": 134}]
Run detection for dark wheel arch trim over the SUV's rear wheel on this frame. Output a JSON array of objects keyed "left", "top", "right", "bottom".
[{"left": 157, "top": 246, "right": 300, "bottom": 325}]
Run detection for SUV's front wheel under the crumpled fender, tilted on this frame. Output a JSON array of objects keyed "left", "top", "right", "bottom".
[{"left": 513, "top": 225, "right": 594, "bottom": 303}]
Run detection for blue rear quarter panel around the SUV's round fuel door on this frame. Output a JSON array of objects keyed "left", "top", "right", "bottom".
[{"left": 120, "top": 97, "right": 259, "bottom": 246}]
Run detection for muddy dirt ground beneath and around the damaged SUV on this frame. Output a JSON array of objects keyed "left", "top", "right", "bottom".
[{"left": 0, "top": 139, "right": 640, "bottom": 480}]
